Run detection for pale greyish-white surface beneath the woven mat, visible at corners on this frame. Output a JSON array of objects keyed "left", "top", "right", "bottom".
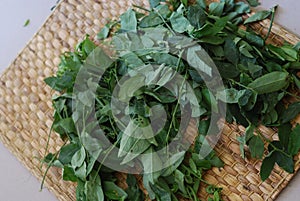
[{"left": 0, "top": 0, "right": 300, "bottom": 201}]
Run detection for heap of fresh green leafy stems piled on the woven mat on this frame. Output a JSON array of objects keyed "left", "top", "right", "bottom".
[{"left": 44, "top": 0, "right": 300, "bottom": 201}]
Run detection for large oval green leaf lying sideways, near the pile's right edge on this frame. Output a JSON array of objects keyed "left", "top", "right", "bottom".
[{"left": 248, "top": 71, "right": 289, "bottom": 94}]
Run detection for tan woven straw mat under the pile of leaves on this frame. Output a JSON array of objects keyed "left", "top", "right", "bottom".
[{"left": 0, "top": 0, "right": 300, "bottom": 201}]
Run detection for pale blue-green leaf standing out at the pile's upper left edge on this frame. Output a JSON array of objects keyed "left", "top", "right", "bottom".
[{"left": 120, "top": 9, "right": 137, "bottom": 32}]
